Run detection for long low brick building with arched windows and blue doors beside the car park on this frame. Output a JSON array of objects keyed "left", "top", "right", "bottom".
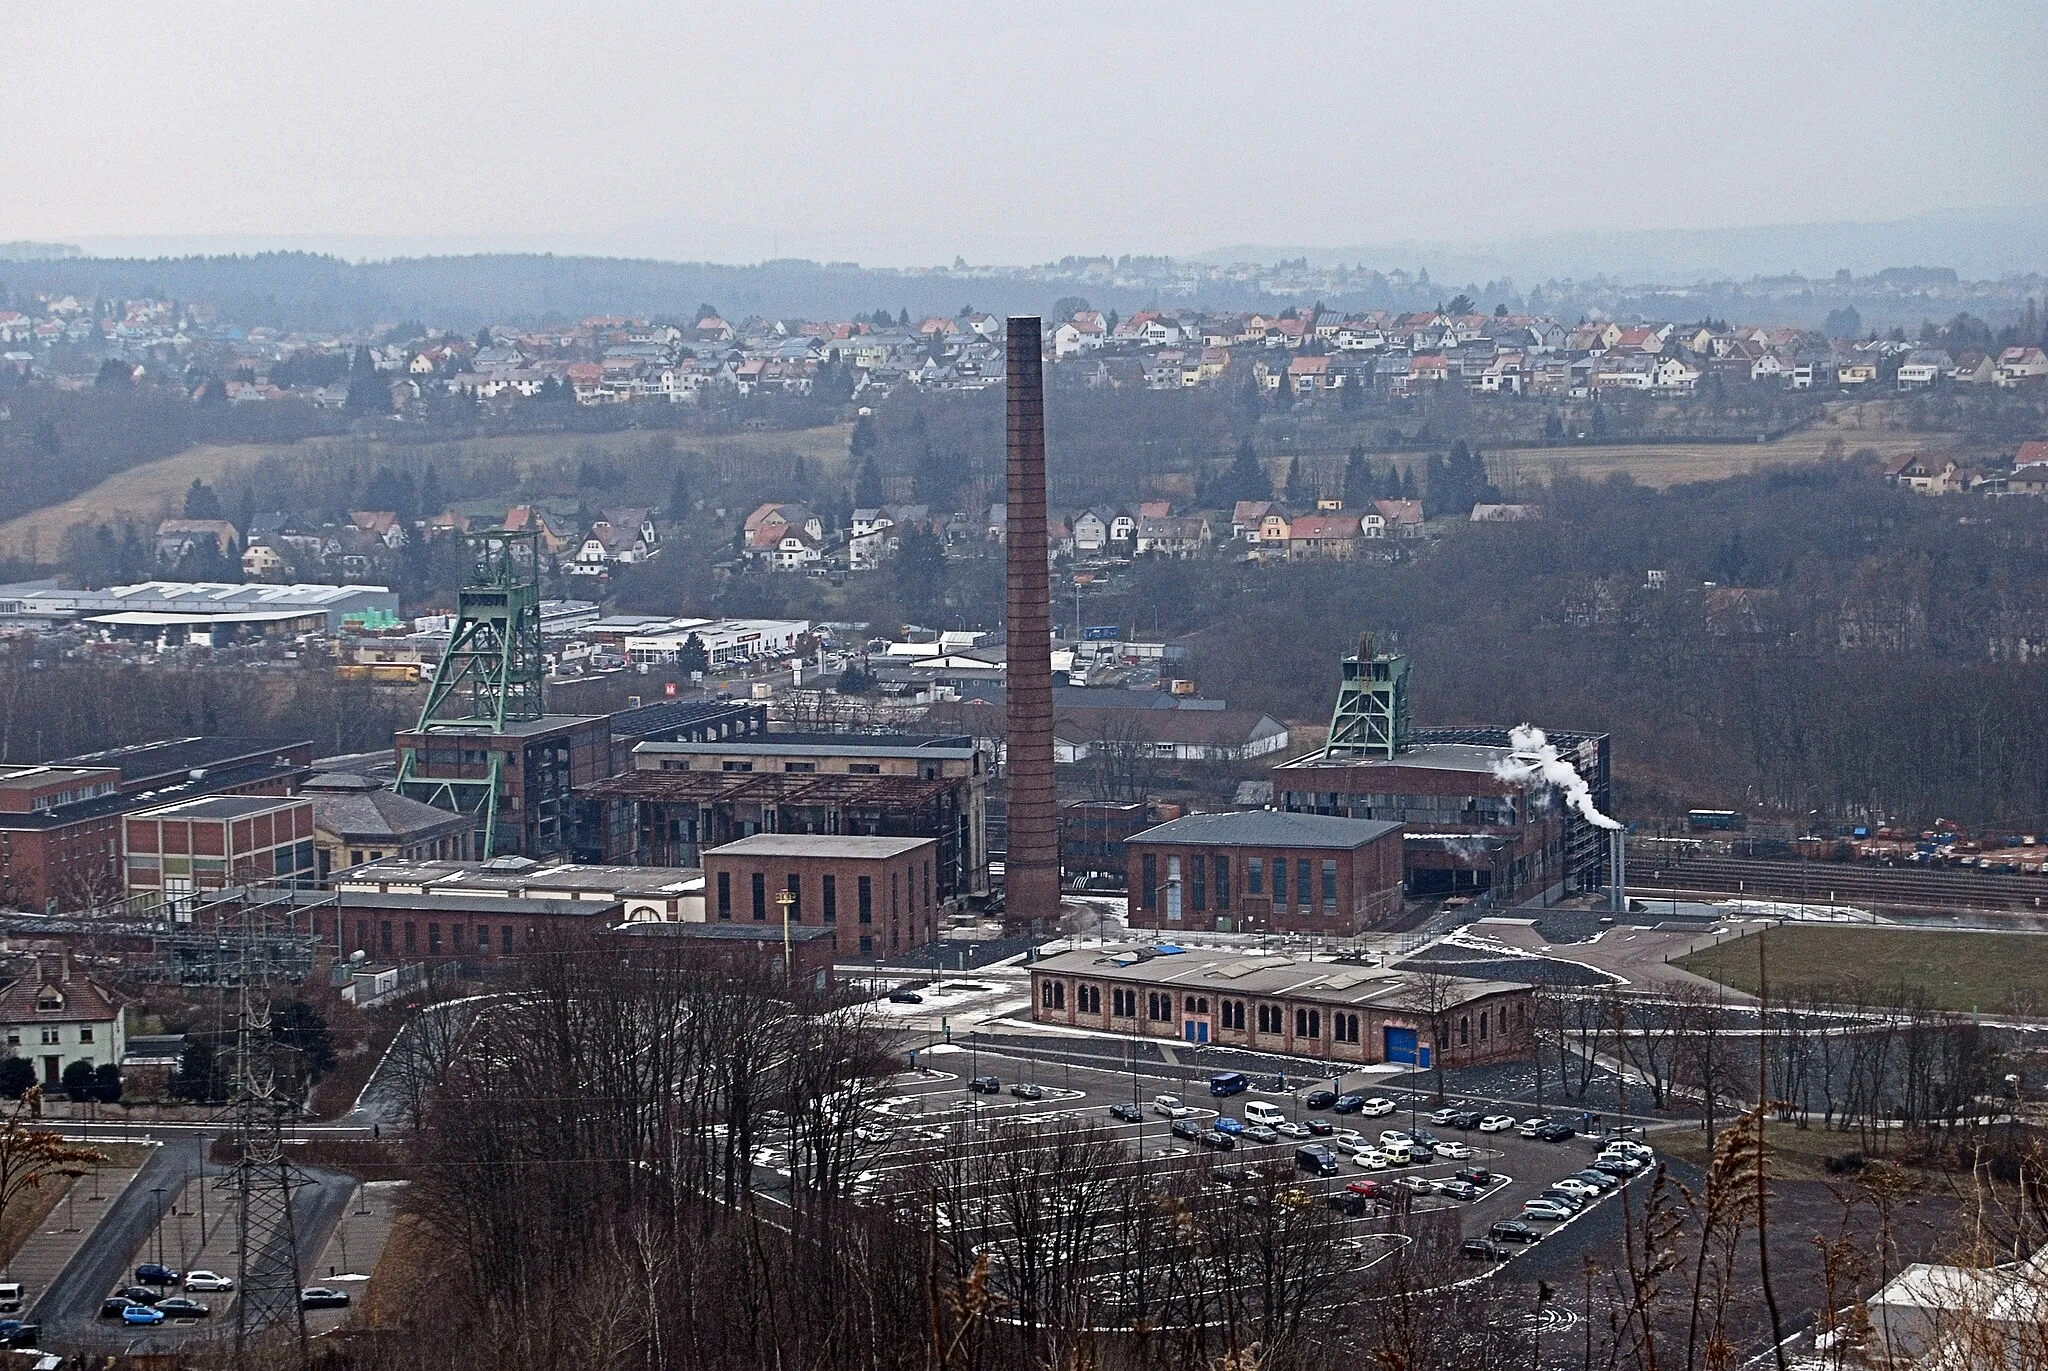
[{"left": 1030, "top": 947, "right": 1536, "bottom": 1068}]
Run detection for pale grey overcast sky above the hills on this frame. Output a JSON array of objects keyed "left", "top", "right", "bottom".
[{"left": 0, "top": 0, "right": 2048, "bottom": 264}]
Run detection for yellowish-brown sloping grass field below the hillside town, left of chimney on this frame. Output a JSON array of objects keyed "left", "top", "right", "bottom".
[{"left": 0, "top": 424, "right": 848, "bottom": 562}]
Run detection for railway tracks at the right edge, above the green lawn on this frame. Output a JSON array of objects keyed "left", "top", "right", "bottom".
[{"left": 1628, "top": 850, "right": 2048, "bottom": 912}]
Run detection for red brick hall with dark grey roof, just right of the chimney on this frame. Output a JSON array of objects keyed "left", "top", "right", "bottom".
[{"left": 1124, "top": 809, "right": 1403, "bottom": 937}]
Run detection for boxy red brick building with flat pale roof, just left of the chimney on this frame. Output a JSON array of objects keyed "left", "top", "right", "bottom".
[{"left": 705, "top": 834, "right": 946, "bottom": 957}]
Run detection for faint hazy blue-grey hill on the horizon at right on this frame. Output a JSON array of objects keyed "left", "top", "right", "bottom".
[{"left": 1202, "top": 205, "right": 2048, "bottom": 287}]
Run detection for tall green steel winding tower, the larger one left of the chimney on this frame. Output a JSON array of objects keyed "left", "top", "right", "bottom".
[{"left": 397, "top": 529, "right": 545, "bottom": 857}]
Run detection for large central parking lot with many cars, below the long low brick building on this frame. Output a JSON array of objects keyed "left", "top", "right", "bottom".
[{"left": 756, "top": 1043, "right": 1662, "bottom": 1271}]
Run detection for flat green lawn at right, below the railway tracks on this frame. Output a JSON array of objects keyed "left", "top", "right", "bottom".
[{"left": 1673, "top": 924, "right": 2048, "bottom": 1014}]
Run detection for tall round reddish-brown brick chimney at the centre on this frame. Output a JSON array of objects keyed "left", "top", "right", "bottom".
[{"left": 1004, "top": 314, "right": 1059, "bottom": 924}]
